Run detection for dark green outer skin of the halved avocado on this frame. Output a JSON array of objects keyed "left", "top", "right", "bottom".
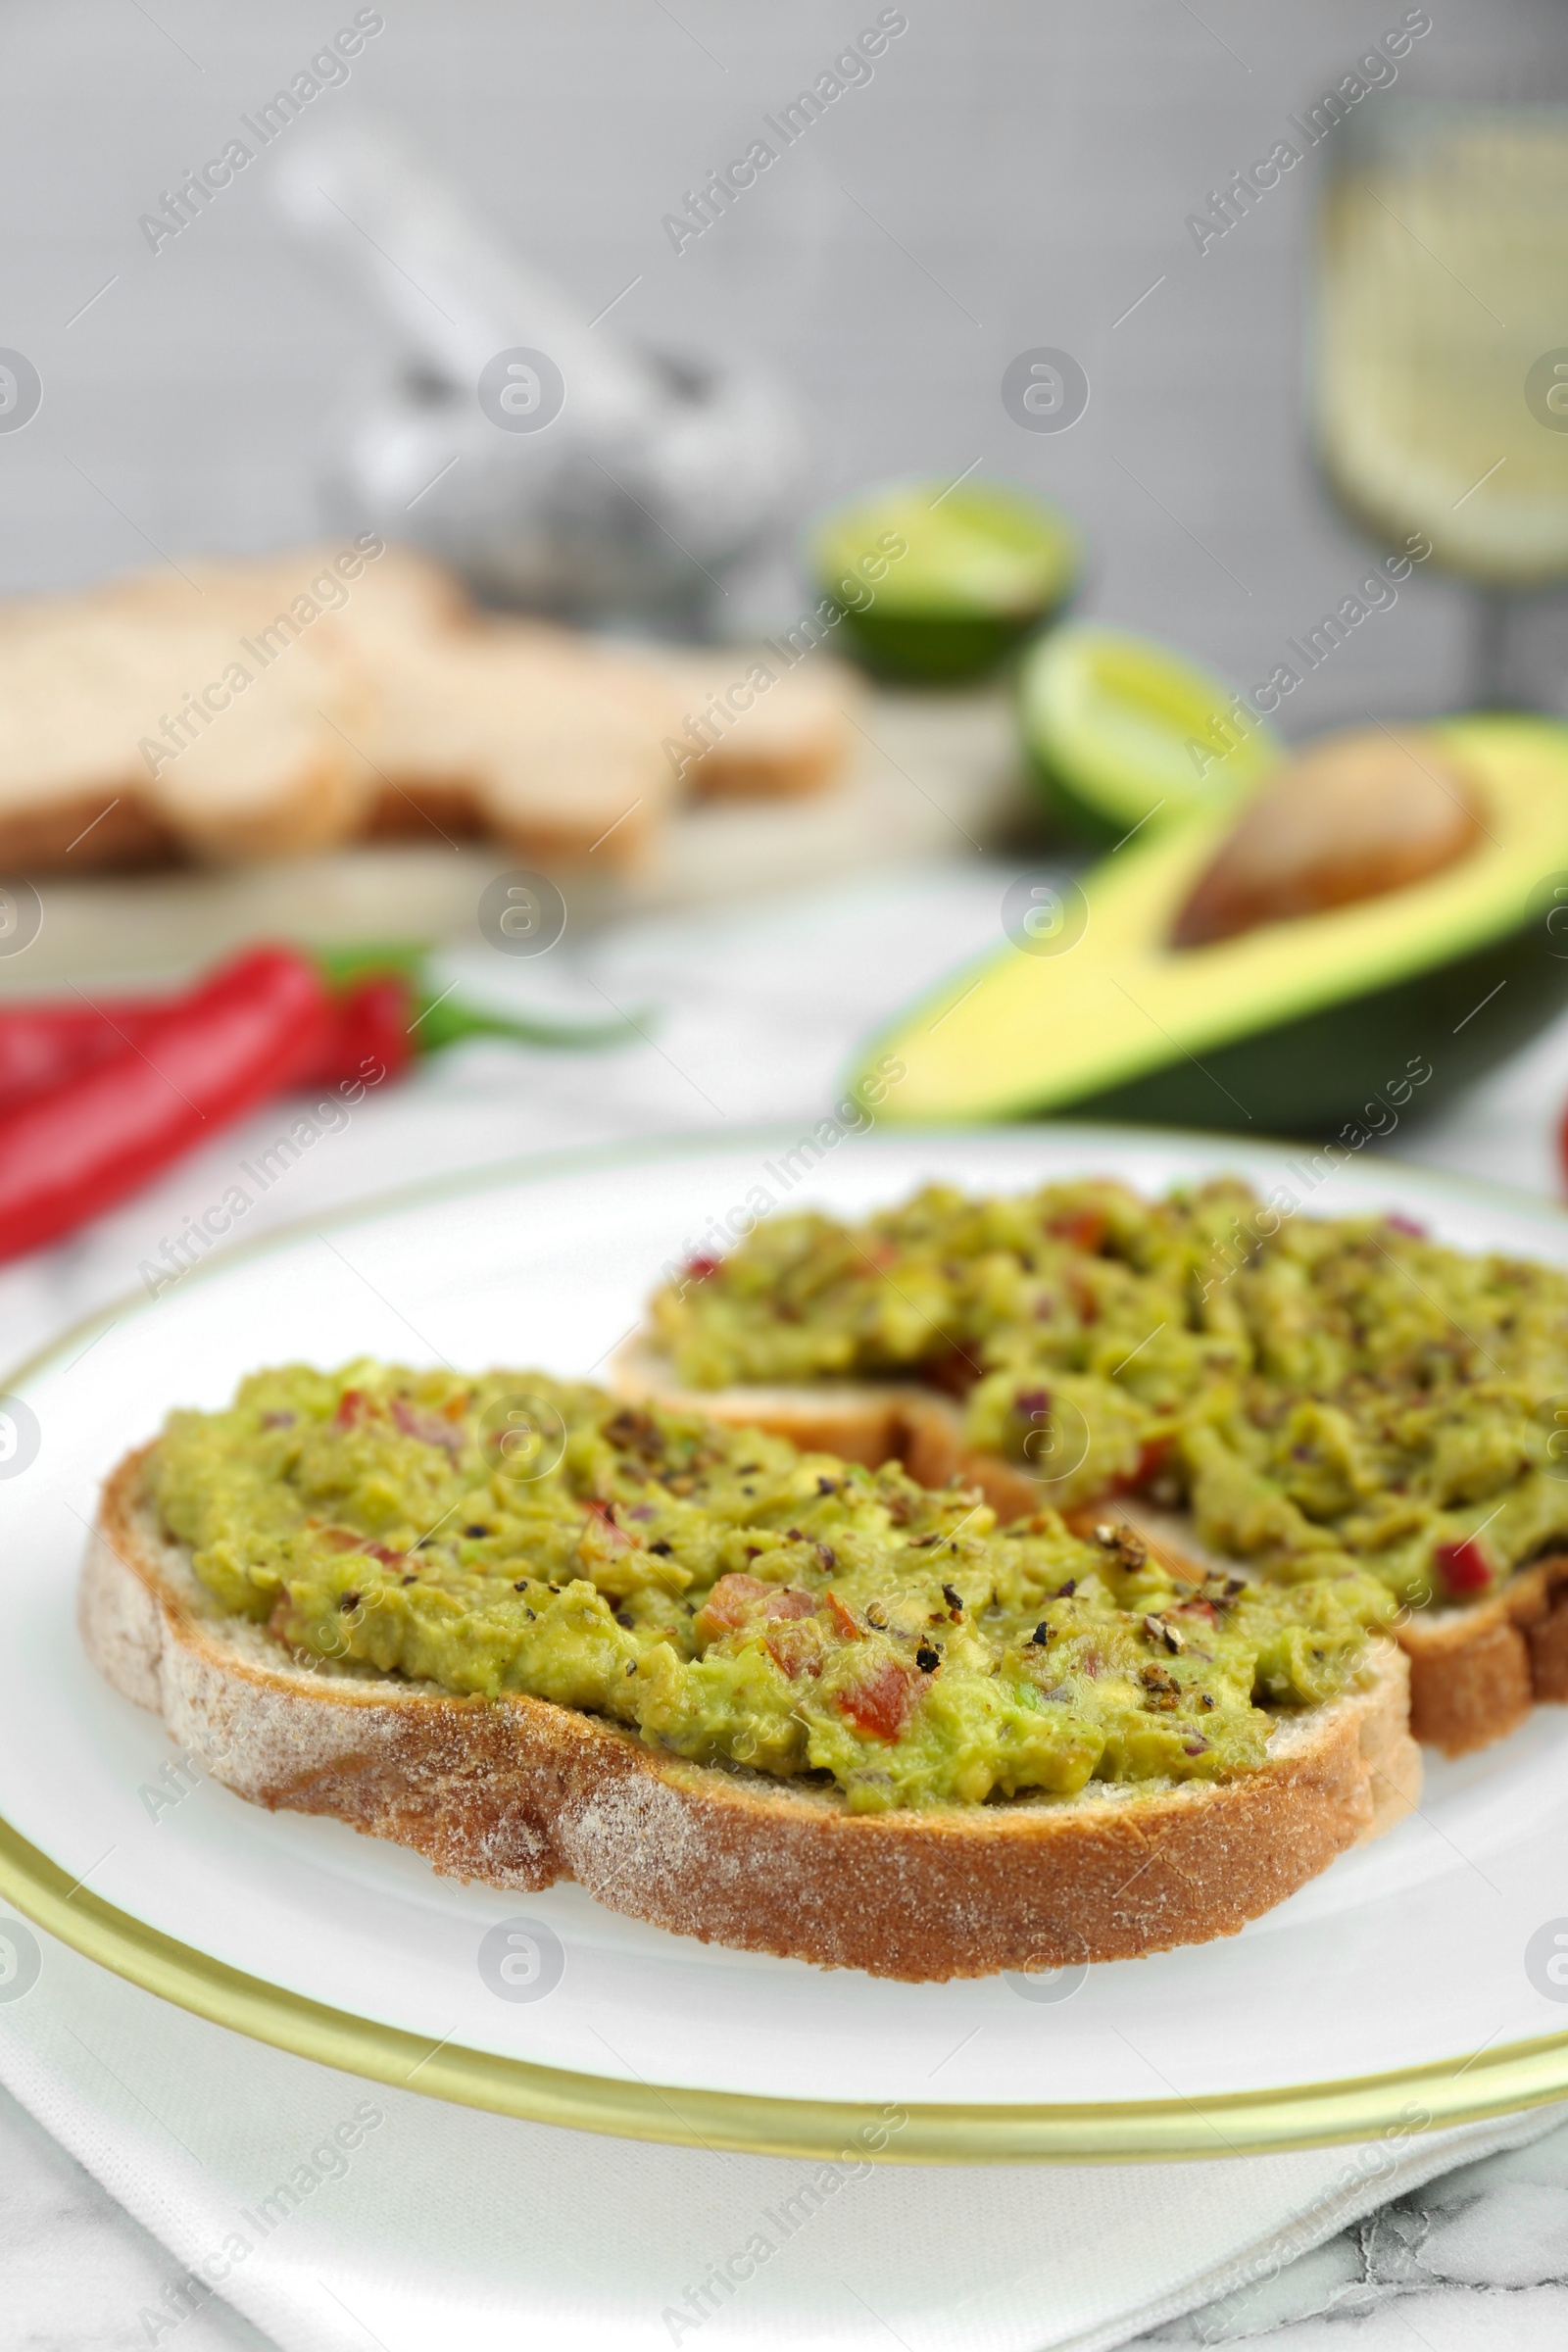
[{"left": 1042, "top": 919, "right": 1568, "bottom": 1141}]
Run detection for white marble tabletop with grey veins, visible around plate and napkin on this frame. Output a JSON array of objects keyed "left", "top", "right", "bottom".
[{"left": 0, "top": 863, "right": 1568, "bottom": 2352}]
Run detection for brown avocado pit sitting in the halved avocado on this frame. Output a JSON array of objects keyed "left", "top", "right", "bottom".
[{"left": 1171, "top": 727, "right": 1484, "bottom": 948}]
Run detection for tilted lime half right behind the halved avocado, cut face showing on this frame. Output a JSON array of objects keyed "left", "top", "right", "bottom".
[{"left": 1018, "top": 621, "right": 1284, "bottom": 849}]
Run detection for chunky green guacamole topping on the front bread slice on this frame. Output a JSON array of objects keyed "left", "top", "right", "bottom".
[{"left": 148, "top": 1362, "right": 1392, "bottom": 1811}]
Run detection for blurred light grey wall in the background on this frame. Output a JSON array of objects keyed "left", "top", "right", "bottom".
[{"left": 0, "top": 0, "right": 1568, "bottom": 729}]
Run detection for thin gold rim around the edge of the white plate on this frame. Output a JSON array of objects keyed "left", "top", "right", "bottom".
[{"left": 0, "top": 1124, "right": 1568, "bottom": 2164}]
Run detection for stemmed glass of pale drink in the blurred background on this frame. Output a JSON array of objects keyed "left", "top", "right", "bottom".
[{"left": 1312, "top": 96, "right": 1568, "bottom": 706}]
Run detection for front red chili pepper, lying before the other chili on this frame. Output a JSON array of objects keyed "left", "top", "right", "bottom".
[{"left": 0, "top": 948, "right": 331, "bottom": 1258}]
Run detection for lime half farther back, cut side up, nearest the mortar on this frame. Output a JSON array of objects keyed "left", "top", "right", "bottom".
[{"left": 807, "top": 477, "right": 1084, "bottom": 684}]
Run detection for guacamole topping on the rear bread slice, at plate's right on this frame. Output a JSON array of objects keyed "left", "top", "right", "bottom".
[{"left": 654, "top": 1181, "right": 1568, "bottom": 1606}]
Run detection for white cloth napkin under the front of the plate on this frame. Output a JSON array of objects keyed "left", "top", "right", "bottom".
[{"left": 0, "top": 1917, "right": 1563, "bottom": 2352}]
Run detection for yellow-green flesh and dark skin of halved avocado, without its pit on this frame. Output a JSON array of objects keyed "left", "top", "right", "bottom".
[{"left": 849, "top": 715, "right": 1568, "bottom": 1141}]
